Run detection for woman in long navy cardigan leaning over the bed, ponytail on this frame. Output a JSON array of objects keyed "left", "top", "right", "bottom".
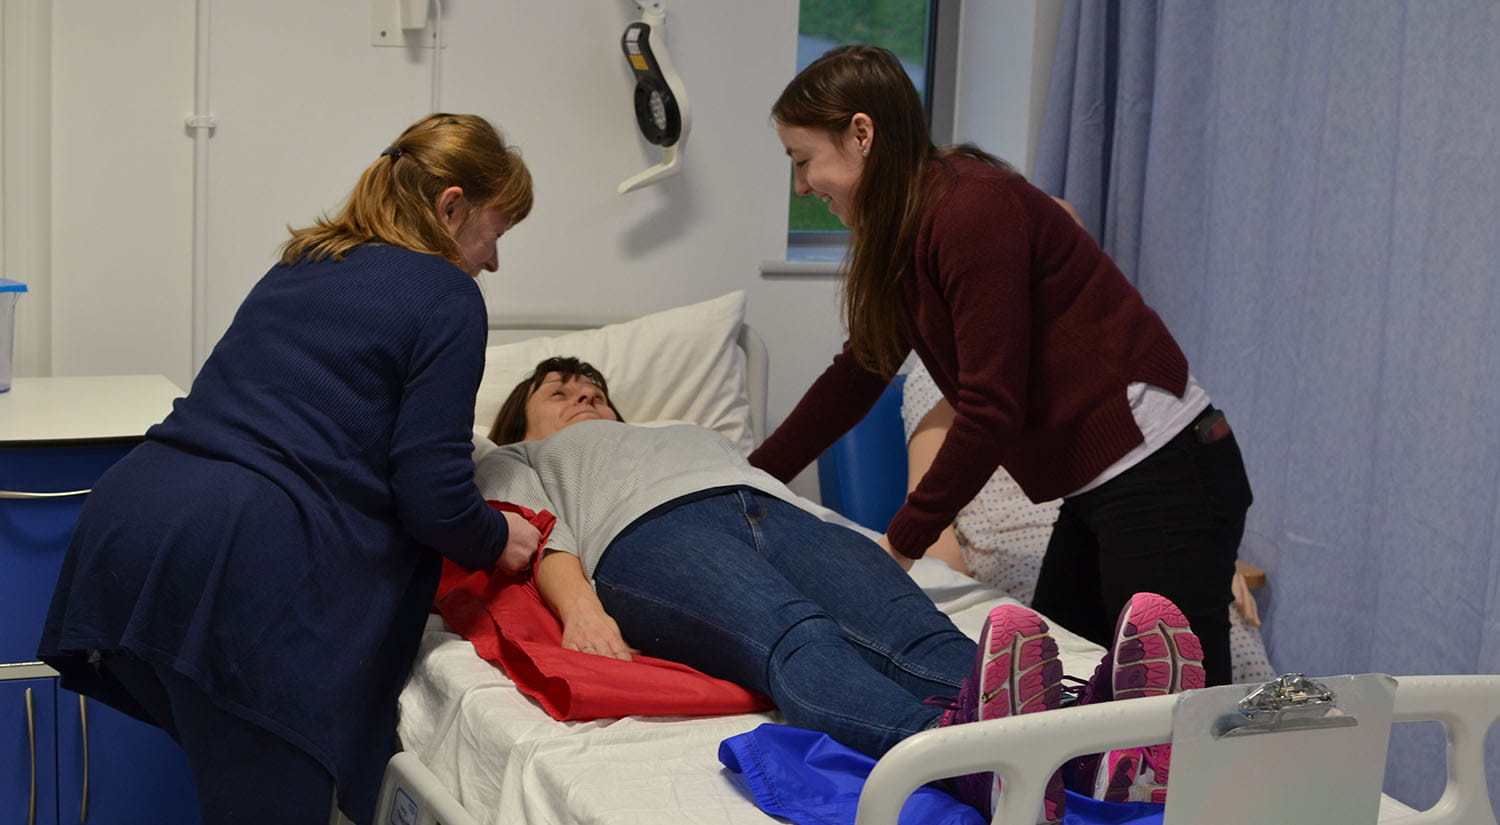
[{"left": 39, "top": 114, "right": 537, "bottom": 825}]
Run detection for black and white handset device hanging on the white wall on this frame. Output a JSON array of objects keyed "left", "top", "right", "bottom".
[{"left": 618, "top": 0, "right": 689, "bottom": 195}]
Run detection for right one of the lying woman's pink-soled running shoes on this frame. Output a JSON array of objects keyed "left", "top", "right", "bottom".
[{"left": 1068, "top": 593, "right": 1205, "bottom": 803}]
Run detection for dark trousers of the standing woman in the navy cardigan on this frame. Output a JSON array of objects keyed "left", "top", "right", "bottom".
[{"left": 101, "top": 654, "right": 333, "bottom": 825}]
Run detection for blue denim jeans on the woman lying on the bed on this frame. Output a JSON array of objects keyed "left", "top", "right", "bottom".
[{"left": 594, "top": 488, "right": 975, "bottom": 758}]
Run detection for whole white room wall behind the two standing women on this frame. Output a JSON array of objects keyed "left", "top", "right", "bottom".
[{"left": 0, "top": 0, "right": 1056, "bottom": 492}]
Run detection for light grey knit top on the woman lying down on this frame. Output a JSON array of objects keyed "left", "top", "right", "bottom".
[{"left": 474, "top": 420, "right": 797, "bottom": 581}]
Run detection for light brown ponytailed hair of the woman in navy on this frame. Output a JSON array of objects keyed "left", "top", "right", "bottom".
[{"left": 281, "top": 114, "right": 531, "bottom": 269}]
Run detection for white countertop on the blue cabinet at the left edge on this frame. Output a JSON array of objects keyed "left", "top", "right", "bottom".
[{"left": 0, "top": 375, "right": 186, "bottom": 446}]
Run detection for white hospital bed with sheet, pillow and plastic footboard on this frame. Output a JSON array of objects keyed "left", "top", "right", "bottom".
[{"left": 377, "top": 293, "right": 1500, "bottom": 825}]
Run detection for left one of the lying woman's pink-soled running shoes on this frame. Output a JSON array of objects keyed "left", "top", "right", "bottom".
[{"left": 939, "top": 605, "right": 1064, "bottom": 824}]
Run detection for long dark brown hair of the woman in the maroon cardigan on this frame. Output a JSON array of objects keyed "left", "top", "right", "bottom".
[{"left": 771, "top": 45, "right": 1010, "bottom": 377}]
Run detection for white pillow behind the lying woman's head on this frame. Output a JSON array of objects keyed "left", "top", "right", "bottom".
[{"left": 474, "top": 291, "right": 755, "bottom": 453}]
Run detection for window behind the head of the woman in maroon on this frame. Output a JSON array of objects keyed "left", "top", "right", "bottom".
[{"left": 788, "top": 0, "right": 957, "bottom": 257}]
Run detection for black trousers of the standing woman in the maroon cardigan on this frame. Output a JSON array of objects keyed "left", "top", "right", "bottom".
[{"left": 1032, "top": 407, "right": 1253, "bottom": 686}]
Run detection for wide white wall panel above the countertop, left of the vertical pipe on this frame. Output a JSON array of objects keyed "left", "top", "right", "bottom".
[{"left": 50, "top": 0, "right": 194, "bottom": 381}]
